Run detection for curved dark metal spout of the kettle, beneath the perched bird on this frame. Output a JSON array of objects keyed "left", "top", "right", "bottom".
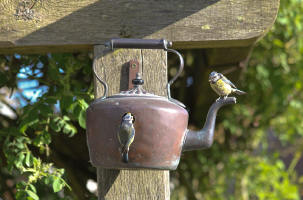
[{"left": 182, "top": 97, "right": 236, "bottom": 151}]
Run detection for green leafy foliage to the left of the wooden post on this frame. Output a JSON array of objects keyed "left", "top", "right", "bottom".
[{"left": 0, "top": 54, "right": 92, "bottom": 200}]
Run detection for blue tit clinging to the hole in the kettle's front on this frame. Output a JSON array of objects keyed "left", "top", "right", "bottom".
[{"left": 118, "top": 112, "right": 135, "bottom": 163}]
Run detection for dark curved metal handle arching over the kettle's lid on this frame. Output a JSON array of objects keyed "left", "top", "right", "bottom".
[{"left": 93, "top": 38, "right": 184, "bottom": 100}]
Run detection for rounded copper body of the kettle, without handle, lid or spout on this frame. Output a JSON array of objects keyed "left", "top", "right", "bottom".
[{"left": 87, "top": 96, "right": 188, "bottom": 170}]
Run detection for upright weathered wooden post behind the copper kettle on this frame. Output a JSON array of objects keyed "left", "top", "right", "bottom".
[{"left": 94, "top": 45, "right": 170, "bottom": 200}]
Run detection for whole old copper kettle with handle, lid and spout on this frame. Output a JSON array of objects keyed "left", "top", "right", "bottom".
[{"left": 86, "top": 39, "right": 236, "bottom": 170}]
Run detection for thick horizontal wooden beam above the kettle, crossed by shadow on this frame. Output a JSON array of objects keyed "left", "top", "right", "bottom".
[{"left": 0, "top": 0, "right": 279, "bottom": 53}]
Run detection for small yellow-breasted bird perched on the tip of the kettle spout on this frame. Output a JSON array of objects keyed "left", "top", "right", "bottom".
[{"left": 208, "top": 72, "right": 246, "bottom": 99}]
